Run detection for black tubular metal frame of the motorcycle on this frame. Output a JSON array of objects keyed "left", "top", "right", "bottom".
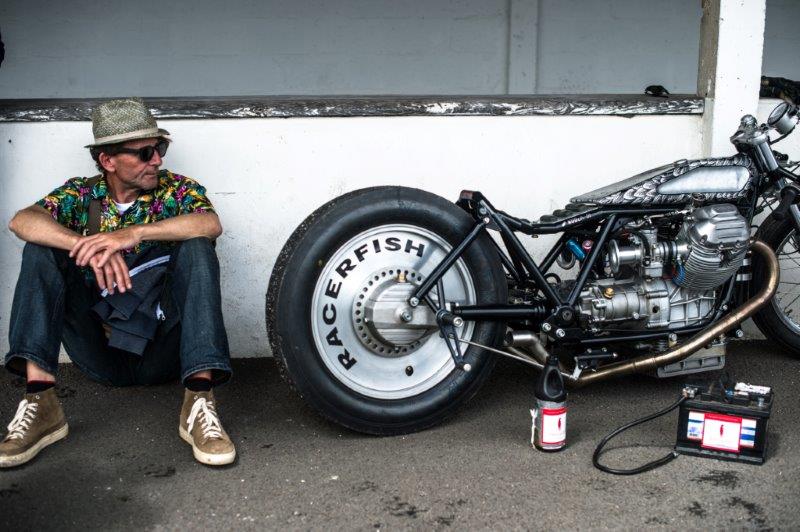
[{"left": 409, "top": 156, "right": 800, "bottom": 348}]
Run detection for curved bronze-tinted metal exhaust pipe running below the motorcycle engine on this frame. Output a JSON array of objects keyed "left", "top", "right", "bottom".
[{"left": 512, "top": 240, "right": 780, "bottom": 388}]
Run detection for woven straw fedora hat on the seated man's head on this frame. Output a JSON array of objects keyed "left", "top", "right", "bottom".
[{"left": 85, "top": 98, "right": 169, "bottom": 148}]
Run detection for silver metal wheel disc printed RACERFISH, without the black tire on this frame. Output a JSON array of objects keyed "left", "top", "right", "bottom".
[{"left": 310, "top": 224, "right": 477, "bottom": 400}]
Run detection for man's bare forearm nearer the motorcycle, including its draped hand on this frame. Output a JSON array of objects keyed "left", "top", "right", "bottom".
[{"left": 70, "top": 212, "right": 222, "bottom": 267}]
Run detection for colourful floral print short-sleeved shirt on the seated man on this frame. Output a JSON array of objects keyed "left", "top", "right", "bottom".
[{"left": 36, "top": 170, "right": 214, "bottom": 255}]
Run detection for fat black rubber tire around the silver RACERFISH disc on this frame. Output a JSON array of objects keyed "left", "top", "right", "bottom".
[{"left": 266, "top": 187, "right": 507, "bottom": 435}]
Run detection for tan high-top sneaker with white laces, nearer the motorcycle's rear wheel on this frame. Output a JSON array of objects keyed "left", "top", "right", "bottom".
[{"left": 178, "top": 390, "right": 236, "bottom": 465}]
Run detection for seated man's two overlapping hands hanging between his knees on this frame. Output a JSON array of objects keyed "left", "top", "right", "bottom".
[{"left": 69, "top": 226, "right": 141, "bottom": 294}]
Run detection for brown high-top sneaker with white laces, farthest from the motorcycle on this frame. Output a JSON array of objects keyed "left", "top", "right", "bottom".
[{"left": 0, "top": 388, "right": 69, "bottom": 467}]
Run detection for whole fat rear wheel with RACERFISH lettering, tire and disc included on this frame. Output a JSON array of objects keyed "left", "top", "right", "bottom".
[{"left": 266, "top": 187, "right": 507, "bottom": 434}]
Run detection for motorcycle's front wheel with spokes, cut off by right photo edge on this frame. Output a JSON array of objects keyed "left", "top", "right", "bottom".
[{"left": 751, "top": 216, "right": 800, "bottom": 357}]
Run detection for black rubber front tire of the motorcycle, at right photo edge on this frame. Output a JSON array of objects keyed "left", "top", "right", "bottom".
[{"left": 751, "top": 216, "right": 800, "bottom": 358}]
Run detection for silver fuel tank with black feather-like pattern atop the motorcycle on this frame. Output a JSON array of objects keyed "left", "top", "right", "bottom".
[{"left": 570, "top": 154, "right": 755, "bottom": 205}]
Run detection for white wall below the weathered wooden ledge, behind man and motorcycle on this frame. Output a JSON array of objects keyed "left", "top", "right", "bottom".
[{"left": 0, "top": 115, "right": 701, "bottom": 356}]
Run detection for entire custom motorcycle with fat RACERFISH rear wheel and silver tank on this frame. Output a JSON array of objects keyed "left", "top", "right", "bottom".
[{"left": 266, "top": 103, "right": 800, "bottom": 434}]
